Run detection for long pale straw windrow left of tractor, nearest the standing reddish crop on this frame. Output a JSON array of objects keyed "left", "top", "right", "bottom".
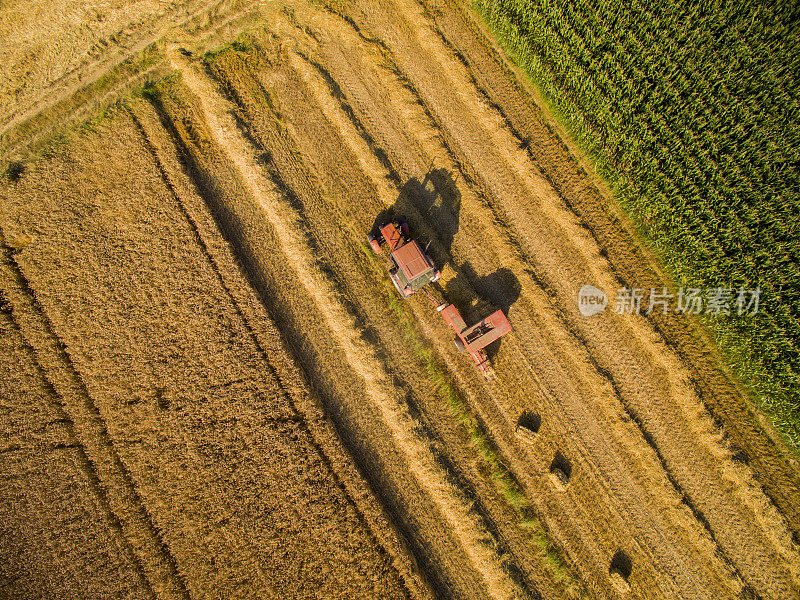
[{"left": 171, "top": 48, "right": 532, "bottom": 598}]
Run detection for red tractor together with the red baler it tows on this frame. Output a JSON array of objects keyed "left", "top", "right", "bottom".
[{"left": 367, "top": 217, "right": 511, "bottom": 378}]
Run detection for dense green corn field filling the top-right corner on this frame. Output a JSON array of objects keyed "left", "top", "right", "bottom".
[{"left": 473, "top": 0, "right": 800, "bottom": 451}]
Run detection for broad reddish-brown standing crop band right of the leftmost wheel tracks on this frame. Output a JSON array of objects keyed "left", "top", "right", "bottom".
[{"left": 3, "top": 101, "right": 424, "bottom": 598}]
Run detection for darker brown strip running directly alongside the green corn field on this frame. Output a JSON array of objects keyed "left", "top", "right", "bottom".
[{"left": 418, "top": 3, "right": 800, "bottom": 548}]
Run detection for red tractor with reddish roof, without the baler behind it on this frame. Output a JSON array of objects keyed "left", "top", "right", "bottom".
[{"left": 367, "top": 217, "right": 441, "bottom": 298}]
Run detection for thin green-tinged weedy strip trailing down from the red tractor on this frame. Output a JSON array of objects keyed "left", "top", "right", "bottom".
[{"left": 361, "top": 244, "right": 586, "bottom": 598}]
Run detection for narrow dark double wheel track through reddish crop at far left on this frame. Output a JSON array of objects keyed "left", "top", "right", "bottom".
[{"left": 0, "top": 232, "right": 191, "bottom": 600}]
